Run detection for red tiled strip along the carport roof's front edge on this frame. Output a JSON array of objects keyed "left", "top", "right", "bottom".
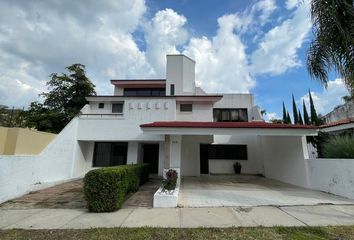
[{"left": 140, "top": 121, "right": 317, "bottom": 129}]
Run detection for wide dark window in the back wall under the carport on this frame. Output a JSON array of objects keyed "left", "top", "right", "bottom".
[{"left": 208, "top": 144, "right": 247, "bottom": 160}]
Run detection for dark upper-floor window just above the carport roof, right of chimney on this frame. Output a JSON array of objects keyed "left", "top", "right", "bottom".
[{"left": 213, "top": 108, "right": 248, "bottom": 122}]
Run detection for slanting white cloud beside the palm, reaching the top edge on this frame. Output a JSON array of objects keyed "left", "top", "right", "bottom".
[{"left": 251, "top": 1, "right": 312, "bottom": 75}]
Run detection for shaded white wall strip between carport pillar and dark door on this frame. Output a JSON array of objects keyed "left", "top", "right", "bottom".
[{"left": 181, "top": 136, "right": 213, "bottom": 176}]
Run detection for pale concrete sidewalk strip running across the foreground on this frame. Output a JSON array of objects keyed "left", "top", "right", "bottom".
[{"left": 0, "top": 205, "right": 354, "bottom": 229}]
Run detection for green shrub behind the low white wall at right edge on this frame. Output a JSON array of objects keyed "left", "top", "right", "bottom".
[{"left": 323, "top": 135, "right": 354, "bottom": 158}]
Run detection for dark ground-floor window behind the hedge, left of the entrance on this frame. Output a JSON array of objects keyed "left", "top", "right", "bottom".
[{"left": 93, "top": 142, "right": 128, "bottom": 167}]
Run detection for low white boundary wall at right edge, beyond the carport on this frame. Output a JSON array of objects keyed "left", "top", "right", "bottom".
[{"left": 306, "top": 159, "right": 354, "bottom": 199}]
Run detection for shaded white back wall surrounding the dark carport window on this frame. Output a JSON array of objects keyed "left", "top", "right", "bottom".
[{"left": 209, "top": 135, "right": 262, "bottom": 174}]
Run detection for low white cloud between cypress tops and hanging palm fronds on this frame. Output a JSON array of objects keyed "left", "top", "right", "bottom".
[{"left": 300, "top": 78, "right": 349, "bottom": 115}]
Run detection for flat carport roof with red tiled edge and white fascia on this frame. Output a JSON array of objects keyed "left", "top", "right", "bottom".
[{"left": 140, "top": 121, "right": 318, "bottom": 136}]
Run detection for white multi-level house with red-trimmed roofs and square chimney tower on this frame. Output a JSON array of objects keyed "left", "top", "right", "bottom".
[{"left": 76, "top": 55, "right": 317, "bottom": 182}]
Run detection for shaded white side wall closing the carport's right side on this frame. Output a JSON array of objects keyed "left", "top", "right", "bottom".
[{"left": 261, "top": 136, "right": 309, "bottom": 187}]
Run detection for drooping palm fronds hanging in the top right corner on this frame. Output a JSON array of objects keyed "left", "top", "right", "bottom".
[{"left": 307, "top": 0, "right": 354, "bottom": 96}]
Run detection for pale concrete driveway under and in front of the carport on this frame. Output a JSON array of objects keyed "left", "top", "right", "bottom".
[{"left": 178, "top": 175, "right": 354, "bottom": 207}]
